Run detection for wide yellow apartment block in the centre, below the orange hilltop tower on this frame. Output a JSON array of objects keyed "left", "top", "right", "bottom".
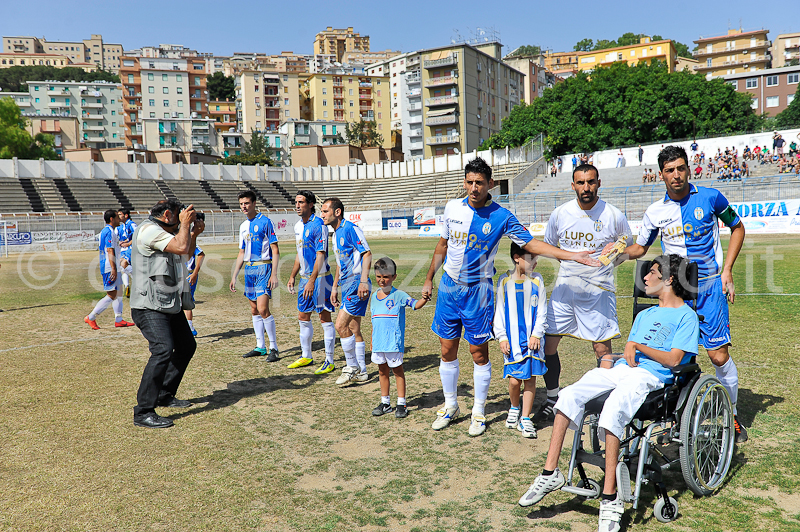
[{"left": 305, "top": 69, "right": 392, "bottom": 149}]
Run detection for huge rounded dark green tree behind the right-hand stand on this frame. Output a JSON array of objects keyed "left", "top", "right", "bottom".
[{"left": 488, "top": 61, "right": 762, "bottom": 154}]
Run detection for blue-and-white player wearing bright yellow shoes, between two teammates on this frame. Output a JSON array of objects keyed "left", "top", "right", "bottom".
[{"left": 286, "top": 190, "right": 336, "bottom": 375}]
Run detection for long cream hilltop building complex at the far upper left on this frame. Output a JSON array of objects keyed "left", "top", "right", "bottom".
[{"left": 0, "top": 34, "right": 123, "bottom": 74}]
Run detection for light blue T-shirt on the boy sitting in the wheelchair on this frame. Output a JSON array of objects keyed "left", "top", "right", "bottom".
[{"left": 615, "top": 304, "right": 700, "bottom": 384}]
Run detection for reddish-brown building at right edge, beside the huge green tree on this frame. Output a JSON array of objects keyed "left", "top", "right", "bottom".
[{"left": 722, "top": 65, "right": 800, "bottom": 116}]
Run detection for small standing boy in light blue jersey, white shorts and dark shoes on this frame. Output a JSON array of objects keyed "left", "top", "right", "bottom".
[{"left": 369, "top": 257, "right": 428, "bottom": 418}]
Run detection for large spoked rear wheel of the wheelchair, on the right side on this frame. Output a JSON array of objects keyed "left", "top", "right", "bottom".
[{"left": 680, "top": 375, "right": 735, "bottom": 495}]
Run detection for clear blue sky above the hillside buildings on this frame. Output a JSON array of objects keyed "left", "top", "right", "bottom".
[{"left": 0, "top": 0, "right": 800, "bottom": 59}]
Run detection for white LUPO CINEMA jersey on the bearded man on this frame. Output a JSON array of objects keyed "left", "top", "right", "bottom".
[{"left": 544, "top": 199, "right": 633, "bottom": 291}]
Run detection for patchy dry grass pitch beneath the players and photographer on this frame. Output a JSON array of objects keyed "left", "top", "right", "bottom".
[{"left": 0, "top": 236, "right": 800, "bottom": 532}]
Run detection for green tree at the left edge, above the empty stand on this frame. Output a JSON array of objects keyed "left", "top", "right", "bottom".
[{"left": 0, "top": 98, "right": 58, "bottom": 160}]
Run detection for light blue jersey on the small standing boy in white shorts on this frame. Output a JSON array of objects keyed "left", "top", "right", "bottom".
[{"left": 369, "top": 287, "right": 417, "bottom": 353}]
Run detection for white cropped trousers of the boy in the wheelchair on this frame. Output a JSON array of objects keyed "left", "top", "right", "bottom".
[{"left": 555, "top": 364, "right": 664, "bottom": 441}]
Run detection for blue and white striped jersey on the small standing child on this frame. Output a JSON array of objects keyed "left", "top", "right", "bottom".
[{"left": 492, "top": 273, "right": 547, "bottom": 364}]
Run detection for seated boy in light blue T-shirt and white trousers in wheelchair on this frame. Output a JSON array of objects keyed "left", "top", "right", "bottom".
[{"left": 519, "top": 255, "right": 700, "bottom": 532}]
